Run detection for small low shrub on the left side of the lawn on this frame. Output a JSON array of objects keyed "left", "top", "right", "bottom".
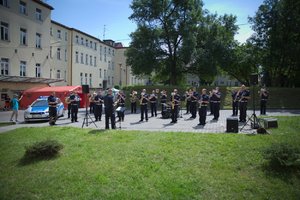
[{"left": 25, "top": 140, "right": 63, "bottom": 158}]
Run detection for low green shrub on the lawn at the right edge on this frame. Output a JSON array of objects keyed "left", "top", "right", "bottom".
[{"left": 263, "top": 143, "right": 300, "bottom": 170}]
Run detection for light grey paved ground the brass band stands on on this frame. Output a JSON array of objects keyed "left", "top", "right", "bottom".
[{"left": 0, "top": 109, "right": 300, "bottom": 133}]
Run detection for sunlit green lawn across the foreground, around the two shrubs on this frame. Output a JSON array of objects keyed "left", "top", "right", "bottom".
[{"left": 0, "top": 117, "right": 300, "bottom": 199}]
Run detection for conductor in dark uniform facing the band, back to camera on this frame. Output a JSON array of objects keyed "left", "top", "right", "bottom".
[{"left": 104, "top": 89, "right": 116, "bottom": 129}]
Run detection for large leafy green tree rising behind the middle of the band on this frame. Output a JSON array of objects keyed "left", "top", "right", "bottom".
[{"left": 126, "top": 0, "right": 203, "bottom": 85}]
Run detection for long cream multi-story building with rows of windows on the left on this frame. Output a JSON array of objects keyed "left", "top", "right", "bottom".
[{"left": 0, "top": 0, "right": 142, "bottom": 107}]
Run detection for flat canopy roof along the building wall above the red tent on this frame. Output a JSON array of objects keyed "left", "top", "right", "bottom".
[{"left": 0, "top": 75, "right": 63, "bottom": 84}]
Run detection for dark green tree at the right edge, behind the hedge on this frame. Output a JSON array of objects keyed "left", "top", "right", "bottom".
[{"left": 249, "top": 0, "right": 300, "bottom": 86}]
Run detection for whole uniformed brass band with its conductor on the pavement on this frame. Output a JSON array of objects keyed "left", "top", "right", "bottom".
[{"left": 58, "top": 85, "right": 269, "bottom": 129}]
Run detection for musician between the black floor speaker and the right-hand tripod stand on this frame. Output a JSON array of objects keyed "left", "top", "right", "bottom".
[{"left": 237, "top": 85, "right": 250, "bottom": 122}]
